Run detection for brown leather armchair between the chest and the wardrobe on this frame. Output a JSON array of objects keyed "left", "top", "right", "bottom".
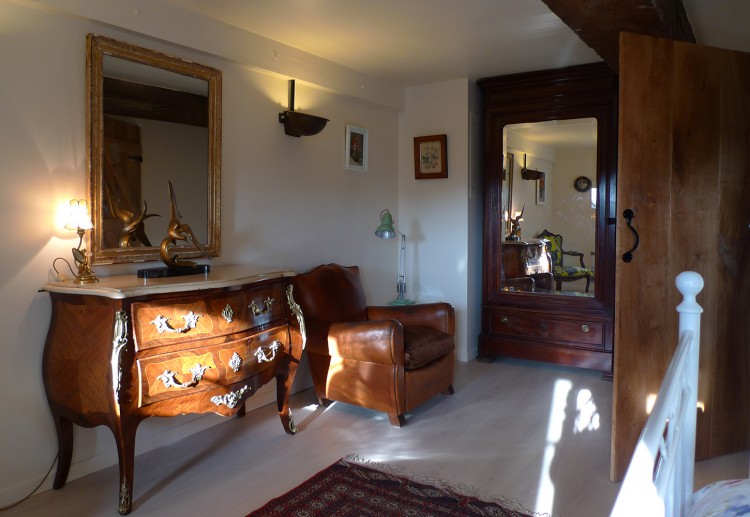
[{"left": 292, "top": 264, "right": 455, "bottom": 427}]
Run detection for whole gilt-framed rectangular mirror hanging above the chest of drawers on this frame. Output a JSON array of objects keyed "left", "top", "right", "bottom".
[{"left": 86, "top": 34, "right": 221, "bottom": 264}]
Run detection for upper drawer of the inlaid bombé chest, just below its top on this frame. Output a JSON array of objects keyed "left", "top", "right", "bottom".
[{"left": 133, "top": 283, "right": 284, "bottom": 350}]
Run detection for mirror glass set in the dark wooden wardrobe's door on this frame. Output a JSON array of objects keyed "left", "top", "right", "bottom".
[{"left": 500, "top": 118, "right": 598, "bottom": 297}]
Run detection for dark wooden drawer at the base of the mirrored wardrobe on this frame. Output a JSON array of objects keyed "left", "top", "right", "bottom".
[{"left": 490, "top": 311, "right": 604, "bottom": 348}]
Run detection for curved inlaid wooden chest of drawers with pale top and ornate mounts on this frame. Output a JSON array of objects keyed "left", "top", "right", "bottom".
[{"left": 43, "top": 266, "right": 305, "bottom": 514}]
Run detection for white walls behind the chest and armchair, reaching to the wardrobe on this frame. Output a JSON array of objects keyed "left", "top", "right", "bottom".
[{"left": 0, "top": 0, "right": 481, "bottom": 506}]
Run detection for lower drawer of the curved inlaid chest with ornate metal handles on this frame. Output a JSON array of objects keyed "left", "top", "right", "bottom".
[{"left": 137, "top": 326, "right": 290, "bottom": 406}]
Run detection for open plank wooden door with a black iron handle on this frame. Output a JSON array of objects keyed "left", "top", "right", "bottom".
[{"left": 611, "top": 34, "right": 750, "bottom": 480}]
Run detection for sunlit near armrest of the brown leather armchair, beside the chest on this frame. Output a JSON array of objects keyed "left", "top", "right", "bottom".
[{"left": 328, "top": 319, "right": 404, "bottom": 365}]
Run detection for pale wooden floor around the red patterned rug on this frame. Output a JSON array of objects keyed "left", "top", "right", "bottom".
[{"left": 2, "top": 360, "right": 748, "bottom": 517}]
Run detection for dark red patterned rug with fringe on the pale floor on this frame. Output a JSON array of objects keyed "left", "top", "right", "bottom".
[{"left": 247, "top": 456, "right": 534, "bottom": 517}]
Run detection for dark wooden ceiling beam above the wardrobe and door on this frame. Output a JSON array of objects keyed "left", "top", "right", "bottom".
[{"left": 542, "top": 0, "right": 695, "bottom": 72}]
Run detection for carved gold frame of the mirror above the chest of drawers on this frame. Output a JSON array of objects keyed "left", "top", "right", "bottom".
[{"left": 86, "top": 34, "right": 221, "bottom": 264}]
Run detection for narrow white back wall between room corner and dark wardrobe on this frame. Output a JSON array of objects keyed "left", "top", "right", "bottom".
[{"left": 393, "top": 79, "right": 481, "bottom": 361}]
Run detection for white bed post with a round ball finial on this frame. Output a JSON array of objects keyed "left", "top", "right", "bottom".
[{"left": 675, "top": 271, "right": 703, "bottom": 512}]
